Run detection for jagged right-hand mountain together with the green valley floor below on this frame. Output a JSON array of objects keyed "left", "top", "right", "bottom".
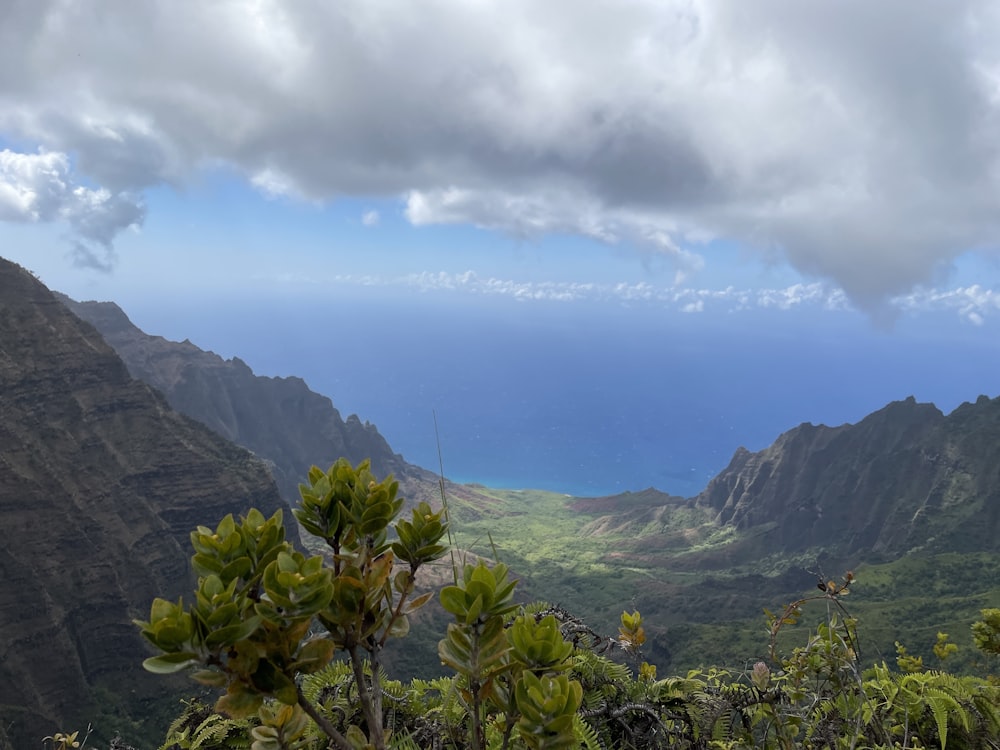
[{"left": 446, "top": 396, "right": 1000, "bottom": 672}]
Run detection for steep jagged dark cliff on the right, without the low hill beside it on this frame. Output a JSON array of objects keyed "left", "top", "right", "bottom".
[{"left": 695, "top": 397, "right": 1000, "bottom": 560}]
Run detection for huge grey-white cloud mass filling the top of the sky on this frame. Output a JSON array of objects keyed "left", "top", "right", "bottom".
[{"left": 0, "top": 0, "right": 1000, "bottom": 302}]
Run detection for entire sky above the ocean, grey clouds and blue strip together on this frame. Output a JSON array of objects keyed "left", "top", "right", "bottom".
[{"left": 0, "top": 0, "right": 1000, "bottom": 490}]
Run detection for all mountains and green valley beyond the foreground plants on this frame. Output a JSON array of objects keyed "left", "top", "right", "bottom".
[{"left": 0, "top": 261, "right": 1000, "bottom": 748}]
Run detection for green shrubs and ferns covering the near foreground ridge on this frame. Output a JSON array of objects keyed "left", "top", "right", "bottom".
[{"left": 123, "top": 461, "right": 1000, "bottom": 750}]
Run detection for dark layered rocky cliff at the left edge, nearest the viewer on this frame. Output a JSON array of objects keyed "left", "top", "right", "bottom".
[{"left": 0, "top": 259, "right": 284, "bottom": 747}]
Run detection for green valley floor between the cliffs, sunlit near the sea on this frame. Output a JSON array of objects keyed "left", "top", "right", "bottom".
[{"left": 438, "top": 487, "right": 1000, "bottom": 674}]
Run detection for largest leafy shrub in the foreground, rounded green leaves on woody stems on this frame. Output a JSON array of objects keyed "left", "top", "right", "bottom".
[{"left": 136, "top": 459, "right": 446, "bottom": 750}]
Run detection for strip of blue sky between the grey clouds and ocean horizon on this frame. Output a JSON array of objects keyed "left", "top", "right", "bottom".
[{"left": 0, "top": 170, "right": 1000, "bottom": 330}]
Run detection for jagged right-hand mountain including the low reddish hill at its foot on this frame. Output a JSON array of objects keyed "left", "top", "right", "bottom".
[{"left": 572, "top": 396, "right": 1000, "bottom": 568}]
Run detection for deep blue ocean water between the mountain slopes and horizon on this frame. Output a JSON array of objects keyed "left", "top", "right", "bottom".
[{"left": 127, "top": 295, "right": 1000, "bottom": 496}]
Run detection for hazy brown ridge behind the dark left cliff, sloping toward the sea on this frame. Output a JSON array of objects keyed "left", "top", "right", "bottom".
[{"left": 61, "top": 297, "right": 437, "bottom": 505}]
